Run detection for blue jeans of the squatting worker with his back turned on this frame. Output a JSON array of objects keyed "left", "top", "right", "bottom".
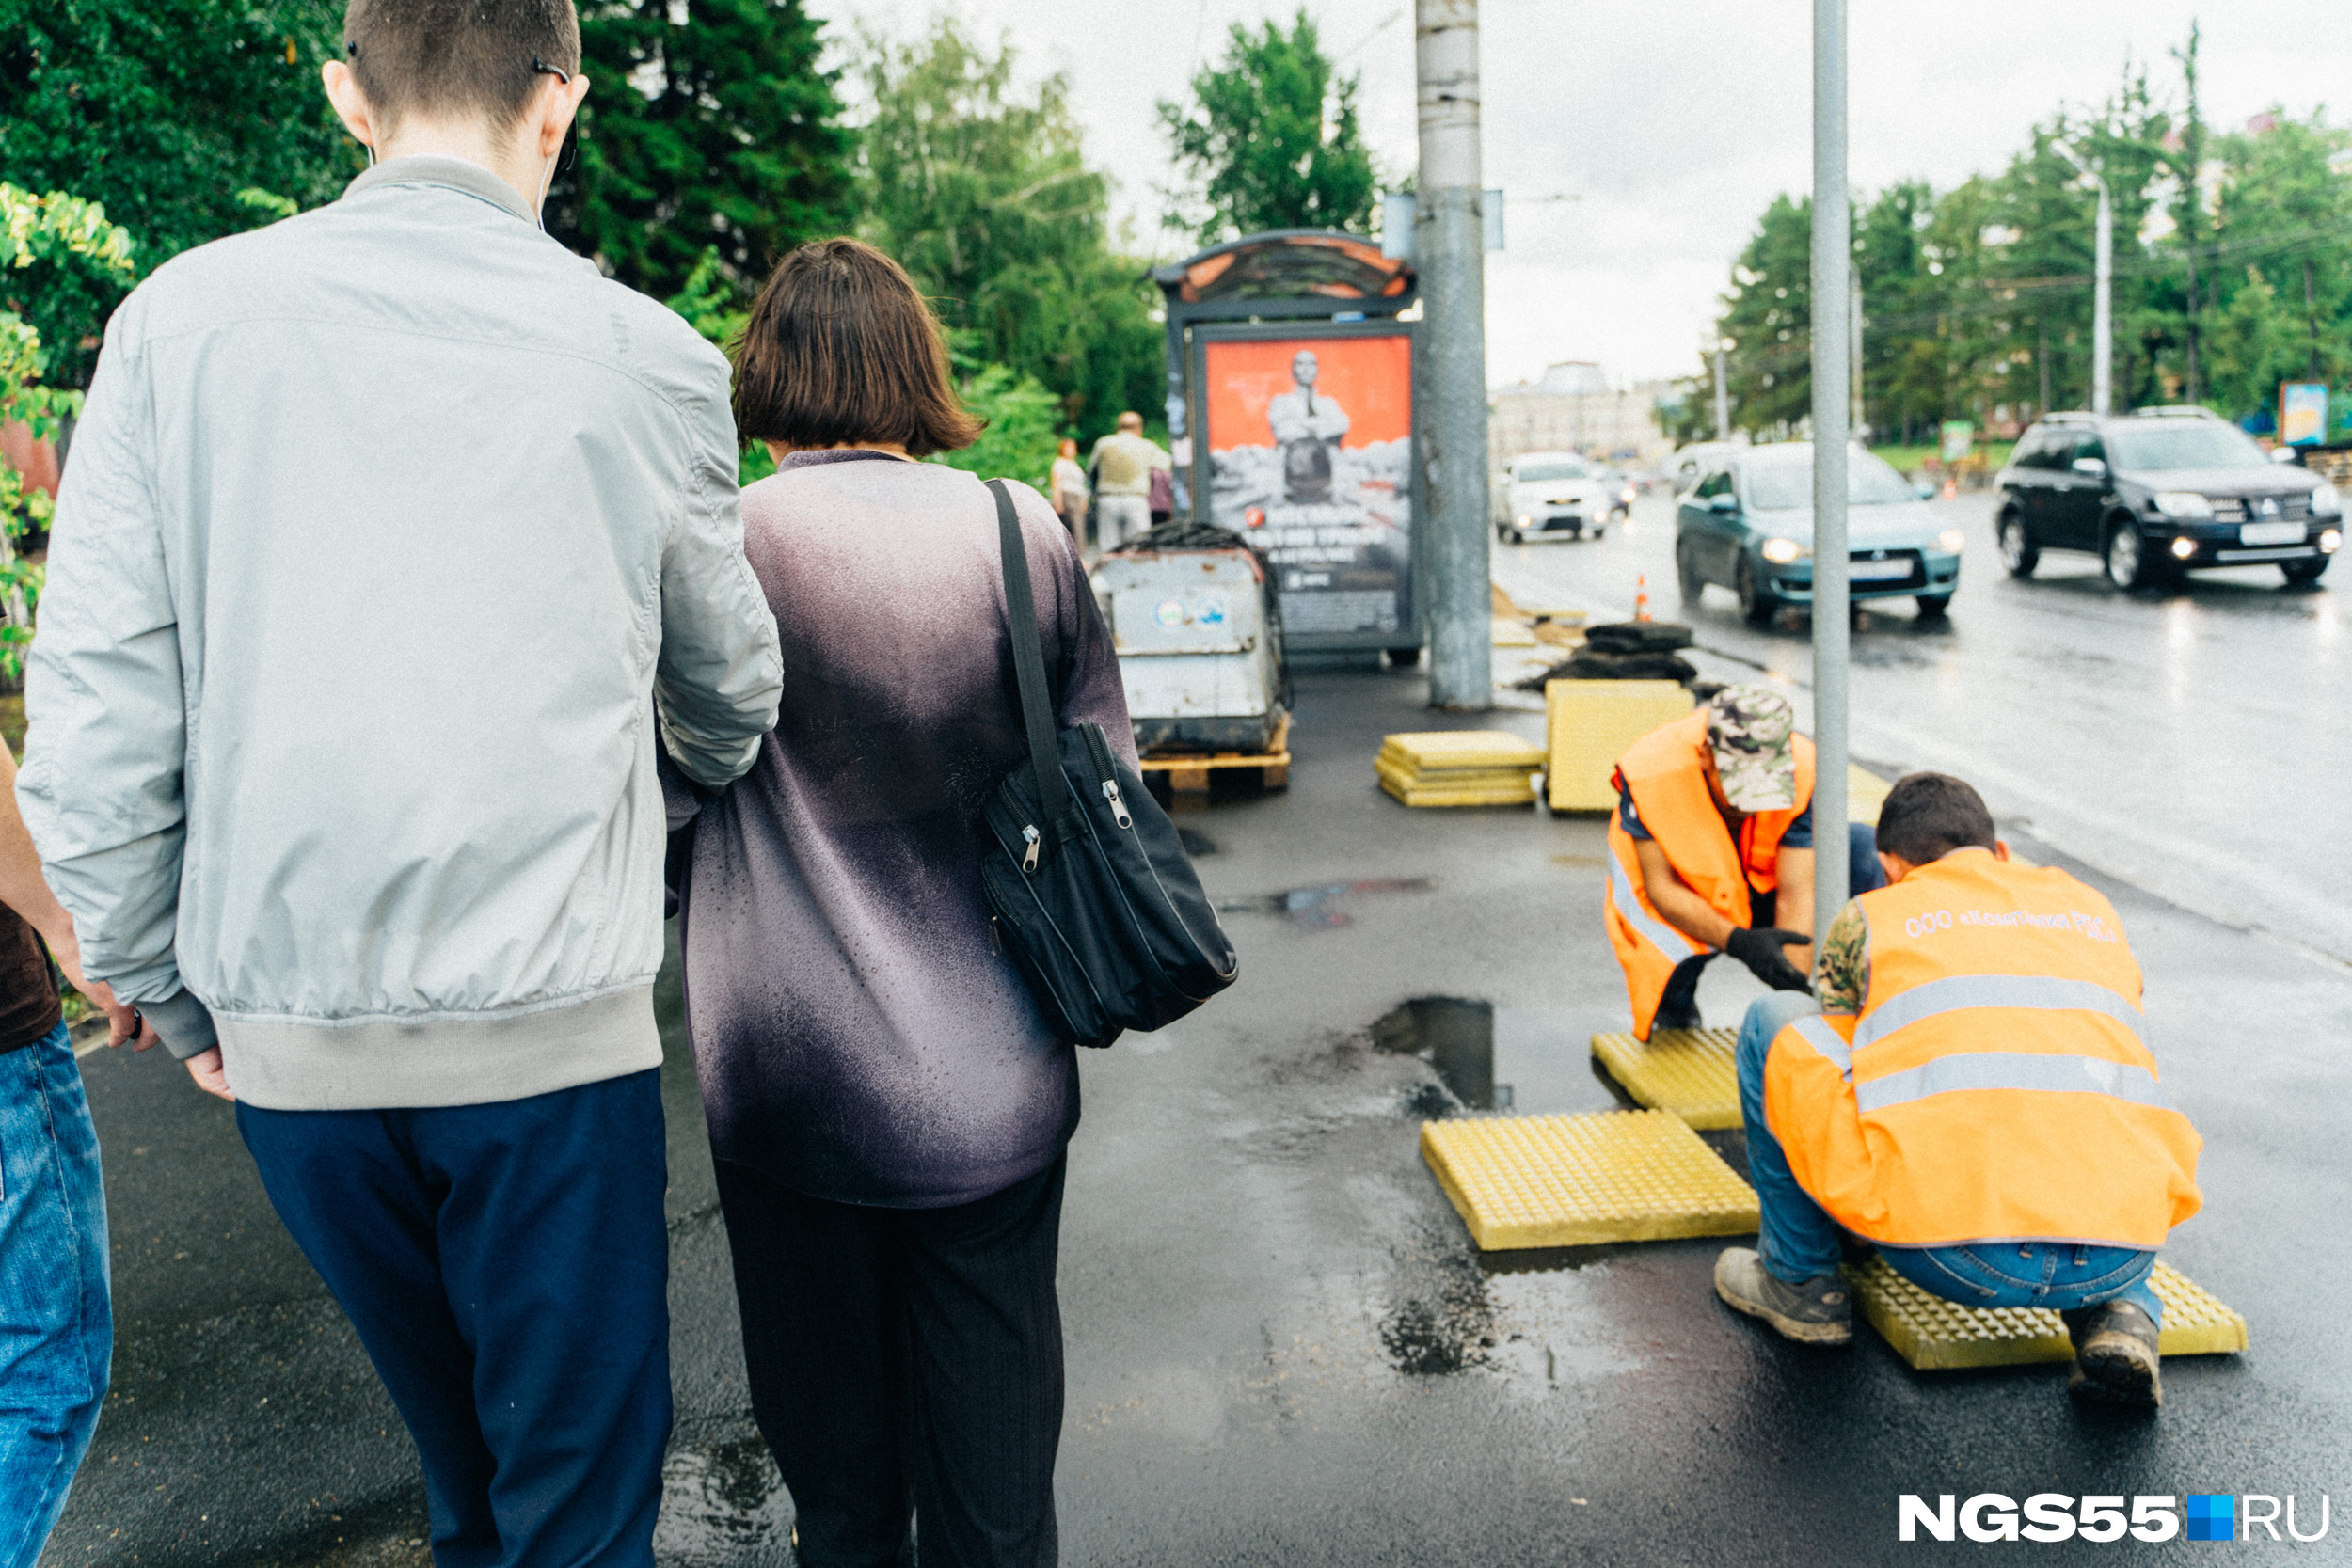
[{"left": 1739, "top": 992, "right": 2164, "bottom": 1328}]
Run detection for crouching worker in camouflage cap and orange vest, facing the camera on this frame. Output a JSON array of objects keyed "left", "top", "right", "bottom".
[{"left": 1604, "top": 687, "right": 1884, "bottom": 1039}]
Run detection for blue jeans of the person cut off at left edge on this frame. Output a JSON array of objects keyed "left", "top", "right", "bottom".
[{"left": 0, "top": 1025, "right": 116, "bottom": 1568}]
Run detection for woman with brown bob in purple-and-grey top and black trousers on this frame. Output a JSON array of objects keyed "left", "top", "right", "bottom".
[{"left": 671, "top": 240, "right": 1134, "bottom": 1568}]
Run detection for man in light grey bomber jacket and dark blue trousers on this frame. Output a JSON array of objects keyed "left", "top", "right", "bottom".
[{"left": 19, "top": 0, "right": 781, "bottom": 1566}]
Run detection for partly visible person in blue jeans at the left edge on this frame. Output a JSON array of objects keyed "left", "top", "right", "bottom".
[{"left": 0, "top": 745, "right": 155, "bottom": 1568}]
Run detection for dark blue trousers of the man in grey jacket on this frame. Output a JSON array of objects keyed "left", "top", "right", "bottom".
[{"left": 238, "top": 1069, "right": 671, "bottom": 1568}]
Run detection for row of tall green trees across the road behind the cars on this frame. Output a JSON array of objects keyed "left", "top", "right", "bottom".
[{"left": 1689, "top": 35, "right": 2352, "bottom": 439}]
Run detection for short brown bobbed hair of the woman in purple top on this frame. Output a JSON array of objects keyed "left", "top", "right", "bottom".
[{"left": 737, "top": 240, "right": 986, "bottom": 458}]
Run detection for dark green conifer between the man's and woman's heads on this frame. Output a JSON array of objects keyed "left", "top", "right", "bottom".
[{"left": 548, "top": 0, "right": 851, "bottom": 298}]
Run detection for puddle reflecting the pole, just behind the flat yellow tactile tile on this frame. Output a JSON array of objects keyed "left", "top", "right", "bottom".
[{"left": 1372, "top": 997, "right": 1630, "bottom": 1119}]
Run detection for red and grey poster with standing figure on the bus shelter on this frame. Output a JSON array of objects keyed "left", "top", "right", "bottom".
[{"left": 1202, "top": 329, "right": 1419, "bottom": 646}]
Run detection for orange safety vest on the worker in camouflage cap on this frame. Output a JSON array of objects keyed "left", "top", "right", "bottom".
[{"left": 1602, "top": 707, "right": 1814, "bottom": 1039}]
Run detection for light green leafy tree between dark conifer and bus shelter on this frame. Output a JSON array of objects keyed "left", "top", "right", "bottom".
[{"left": 854, "top": 19, "right": 1165, "bottom": 437}]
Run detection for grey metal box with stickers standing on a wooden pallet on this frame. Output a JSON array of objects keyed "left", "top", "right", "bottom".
[{"left": 1091, "top": 533, "right": 1289, "bottom": 752}]
